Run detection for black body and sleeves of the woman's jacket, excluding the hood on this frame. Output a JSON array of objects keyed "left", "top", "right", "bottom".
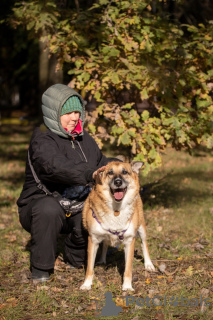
[{"left": 17, "top": 128, "right": 117, "bottom": 207}]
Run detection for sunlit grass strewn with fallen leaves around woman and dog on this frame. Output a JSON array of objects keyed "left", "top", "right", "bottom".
[{"left": 0, "top": 125, "right": 213, "bottom": 320}]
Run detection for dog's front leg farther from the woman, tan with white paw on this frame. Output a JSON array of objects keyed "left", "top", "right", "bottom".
[{"left": 122, "top": 238, "right": 135, "bottom": 291}]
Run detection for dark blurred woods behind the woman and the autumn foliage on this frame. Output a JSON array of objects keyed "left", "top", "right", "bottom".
[{"left": 0, "top": 0, "right": 213, "bottom": 118}]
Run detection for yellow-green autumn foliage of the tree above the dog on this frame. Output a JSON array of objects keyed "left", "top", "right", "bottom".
[{"left": 9, "top": 0, "right": 213, "bottom": 172}]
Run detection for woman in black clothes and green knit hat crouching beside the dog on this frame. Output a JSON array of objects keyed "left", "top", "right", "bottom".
[{"left": 17, "top": 84, "right": 117, "bottom": 281}]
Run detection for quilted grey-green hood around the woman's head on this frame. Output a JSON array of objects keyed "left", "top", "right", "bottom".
[{"left": 42, "top": 84, "right": 86, "bottom": 138}]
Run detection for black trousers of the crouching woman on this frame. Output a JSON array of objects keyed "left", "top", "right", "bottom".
[{"left": 19, "top": 196, "right": 88, "bottom": 270}]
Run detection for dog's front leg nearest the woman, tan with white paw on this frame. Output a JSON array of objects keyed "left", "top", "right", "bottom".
[{"left": 80, "top": 235, "right": 99, "bottom": 290}]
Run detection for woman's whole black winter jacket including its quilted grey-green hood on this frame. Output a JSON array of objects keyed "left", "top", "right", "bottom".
[{"left": 17, "top": 84, "right": 119, "bottom": 208}]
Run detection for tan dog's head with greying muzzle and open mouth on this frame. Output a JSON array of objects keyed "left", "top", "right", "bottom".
[{"left": 95, "top": 161, "right": 143, "bottom": 202}]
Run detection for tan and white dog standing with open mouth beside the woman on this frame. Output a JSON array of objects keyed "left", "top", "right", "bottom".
[{"left": 80, "top": 161, "right": 155, "bottom": 291}]
